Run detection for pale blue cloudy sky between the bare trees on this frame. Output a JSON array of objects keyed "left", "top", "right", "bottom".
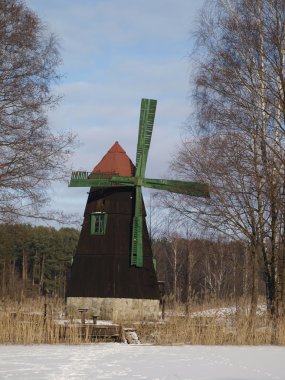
[{"left": 22, "top": 0, "right": 204, "bottom": 224}]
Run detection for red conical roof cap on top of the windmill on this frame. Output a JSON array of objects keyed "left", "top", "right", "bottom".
[{"left": 92, "top": 141, "right": 135, "bottom": 177}]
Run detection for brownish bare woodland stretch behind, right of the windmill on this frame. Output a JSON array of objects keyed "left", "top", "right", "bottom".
[{"left": 153, "top": 236, "right": 264, "bottom": 306}]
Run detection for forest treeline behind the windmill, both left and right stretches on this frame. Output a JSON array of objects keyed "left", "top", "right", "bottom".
[{"left": 0, "top": 224, "right": 258, "bottom": 305}]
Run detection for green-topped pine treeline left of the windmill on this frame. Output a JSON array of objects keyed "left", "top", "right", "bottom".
[{"left": 0, "top": 224, "right": 79, "bottom": 299}]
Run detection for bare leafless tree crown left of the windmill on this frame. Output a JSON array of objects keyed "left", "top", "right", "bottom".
[{"left": 0, "top": 0, "right": 74, "bottom": 221}]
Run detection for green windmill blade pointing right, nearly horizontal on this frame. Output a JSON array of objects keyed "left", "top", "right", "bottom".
[{"left": 142, "top": 178, "right": 209, "bottom": 197}]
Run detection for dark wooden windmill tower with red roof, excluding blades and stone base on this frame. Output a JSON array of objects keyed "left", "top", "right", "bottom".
[{"left": 67, "top": 142, "right": 159, "bottom": 299}]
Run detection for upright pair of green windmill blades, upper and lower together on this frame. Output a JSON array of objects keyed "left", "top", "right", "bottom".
[{"left": 131, "top": 99, "right": 157, "bottom": 267}]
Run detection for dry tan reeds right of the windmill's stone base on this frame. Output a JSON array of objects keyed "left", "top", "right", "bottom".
[{"left": 136, "top": 316, "right": 285, "bottom": 345}]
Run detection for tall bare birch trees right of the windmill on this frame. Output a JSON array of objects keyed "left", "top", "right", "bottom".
[{"left": 164, "top": 0, "right": 285, "bottom": 316}]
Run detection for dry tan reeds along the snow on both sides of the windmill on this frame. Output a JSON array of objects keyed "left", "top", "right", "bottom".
[{"left": 0, "top": 299, "right": 285, "bottom": 345}]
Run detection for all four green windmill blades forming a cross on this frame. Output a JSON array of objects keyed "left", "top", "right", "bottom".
[{"left": 69, "top": 99, "right": 209, "bottom": 267}]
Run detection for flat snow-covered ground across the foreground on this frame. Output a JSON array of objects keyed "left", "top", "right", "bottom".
[{"left": 0, "top": 343, "right": 285, "bottom": 380}]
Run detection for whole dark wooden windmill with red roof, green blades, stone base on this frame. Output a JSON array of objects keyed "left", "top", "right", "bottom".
[{"left": 67, "top": 99, "right": 208, "bottom": 319}]
